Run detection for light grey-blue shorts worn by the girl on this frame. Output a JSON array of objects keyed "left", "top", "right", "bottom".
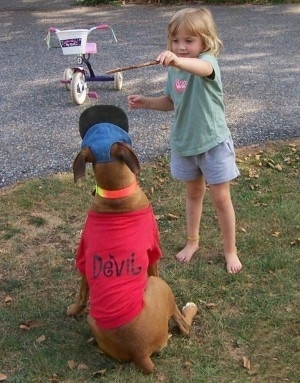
[{"left": 170, "top": 136, "right": 240, "bottom": 185}]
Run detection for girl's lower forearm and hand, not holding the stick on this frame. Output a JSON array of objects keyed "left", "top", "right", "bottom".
[{"left": 127, "top": 94, "right": 174, "bottom": 112}]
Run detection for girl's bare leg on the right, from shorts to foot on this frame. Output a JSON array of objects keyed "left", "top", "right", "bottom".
[{"left": 209, "top": 182, "right": 242, "bottom": 274}]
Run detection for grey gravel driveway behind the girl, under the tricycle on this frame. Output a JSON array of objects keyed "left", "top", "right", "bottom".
[{"left": 0, "top": 0, "right": 300, "bottom": 188}]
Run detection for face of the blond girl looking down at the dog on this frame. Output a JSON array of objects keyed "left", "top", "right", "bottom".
[{"left": 171, "top": 28, "right": 203, "bottom": 58}]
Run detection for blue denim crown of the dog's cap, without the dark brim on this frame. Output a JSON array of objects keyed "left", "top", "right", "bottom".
[{"left": 81, "top": 122, "right": 131, "bottom": 162}]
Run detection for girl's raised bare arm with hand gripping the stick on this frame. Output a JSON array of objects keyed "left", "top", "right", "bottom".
[{"left": 156, "top": 51, "right": 214, "bottom": 77}]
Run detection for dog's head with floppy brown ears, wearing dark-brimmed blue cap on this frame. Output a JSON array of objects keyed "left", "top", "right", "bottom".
[{"left": 73, "top": 105, "right": 140, "bottom": 182}]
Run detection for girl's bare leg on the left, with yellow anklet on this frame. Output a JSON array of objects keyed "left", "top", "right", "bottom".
[{"left": 176, "top": 177, "right": 206, "bottom": 262}]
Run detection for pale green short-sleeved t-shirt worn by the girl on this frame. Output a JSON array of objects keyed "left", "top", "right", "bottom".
[{"left": 165, "top": 53, "right": 230, "bottom": 156}]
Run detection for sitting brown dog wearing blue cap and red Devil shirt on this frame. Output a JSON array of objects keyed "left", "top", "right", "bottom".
[{"left": 67, "top": 105, "right": 197, "bottom": 373}]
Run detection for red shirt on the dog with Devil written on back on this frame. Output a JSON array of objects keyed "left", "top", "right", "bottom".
[{"left": 76, "top": 205, "right": 161, "bottom": 329}]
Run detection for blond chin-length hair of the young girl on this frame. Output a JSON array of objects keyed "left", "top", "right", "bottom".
[{"left": 168, "top": 7, "right": 223, "bottom": 56}]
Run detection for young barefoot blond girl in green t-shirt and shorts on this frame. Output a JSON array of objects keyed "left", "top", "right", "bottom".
[{"left": 128, "top": 7, "right": 242, "bottom": 274}]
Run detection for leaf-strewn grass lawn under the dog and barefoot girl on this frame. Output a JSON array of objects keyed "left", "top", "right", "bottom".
[{"left": 0, "top": 140, "right": 300, "bottom": 383}]
